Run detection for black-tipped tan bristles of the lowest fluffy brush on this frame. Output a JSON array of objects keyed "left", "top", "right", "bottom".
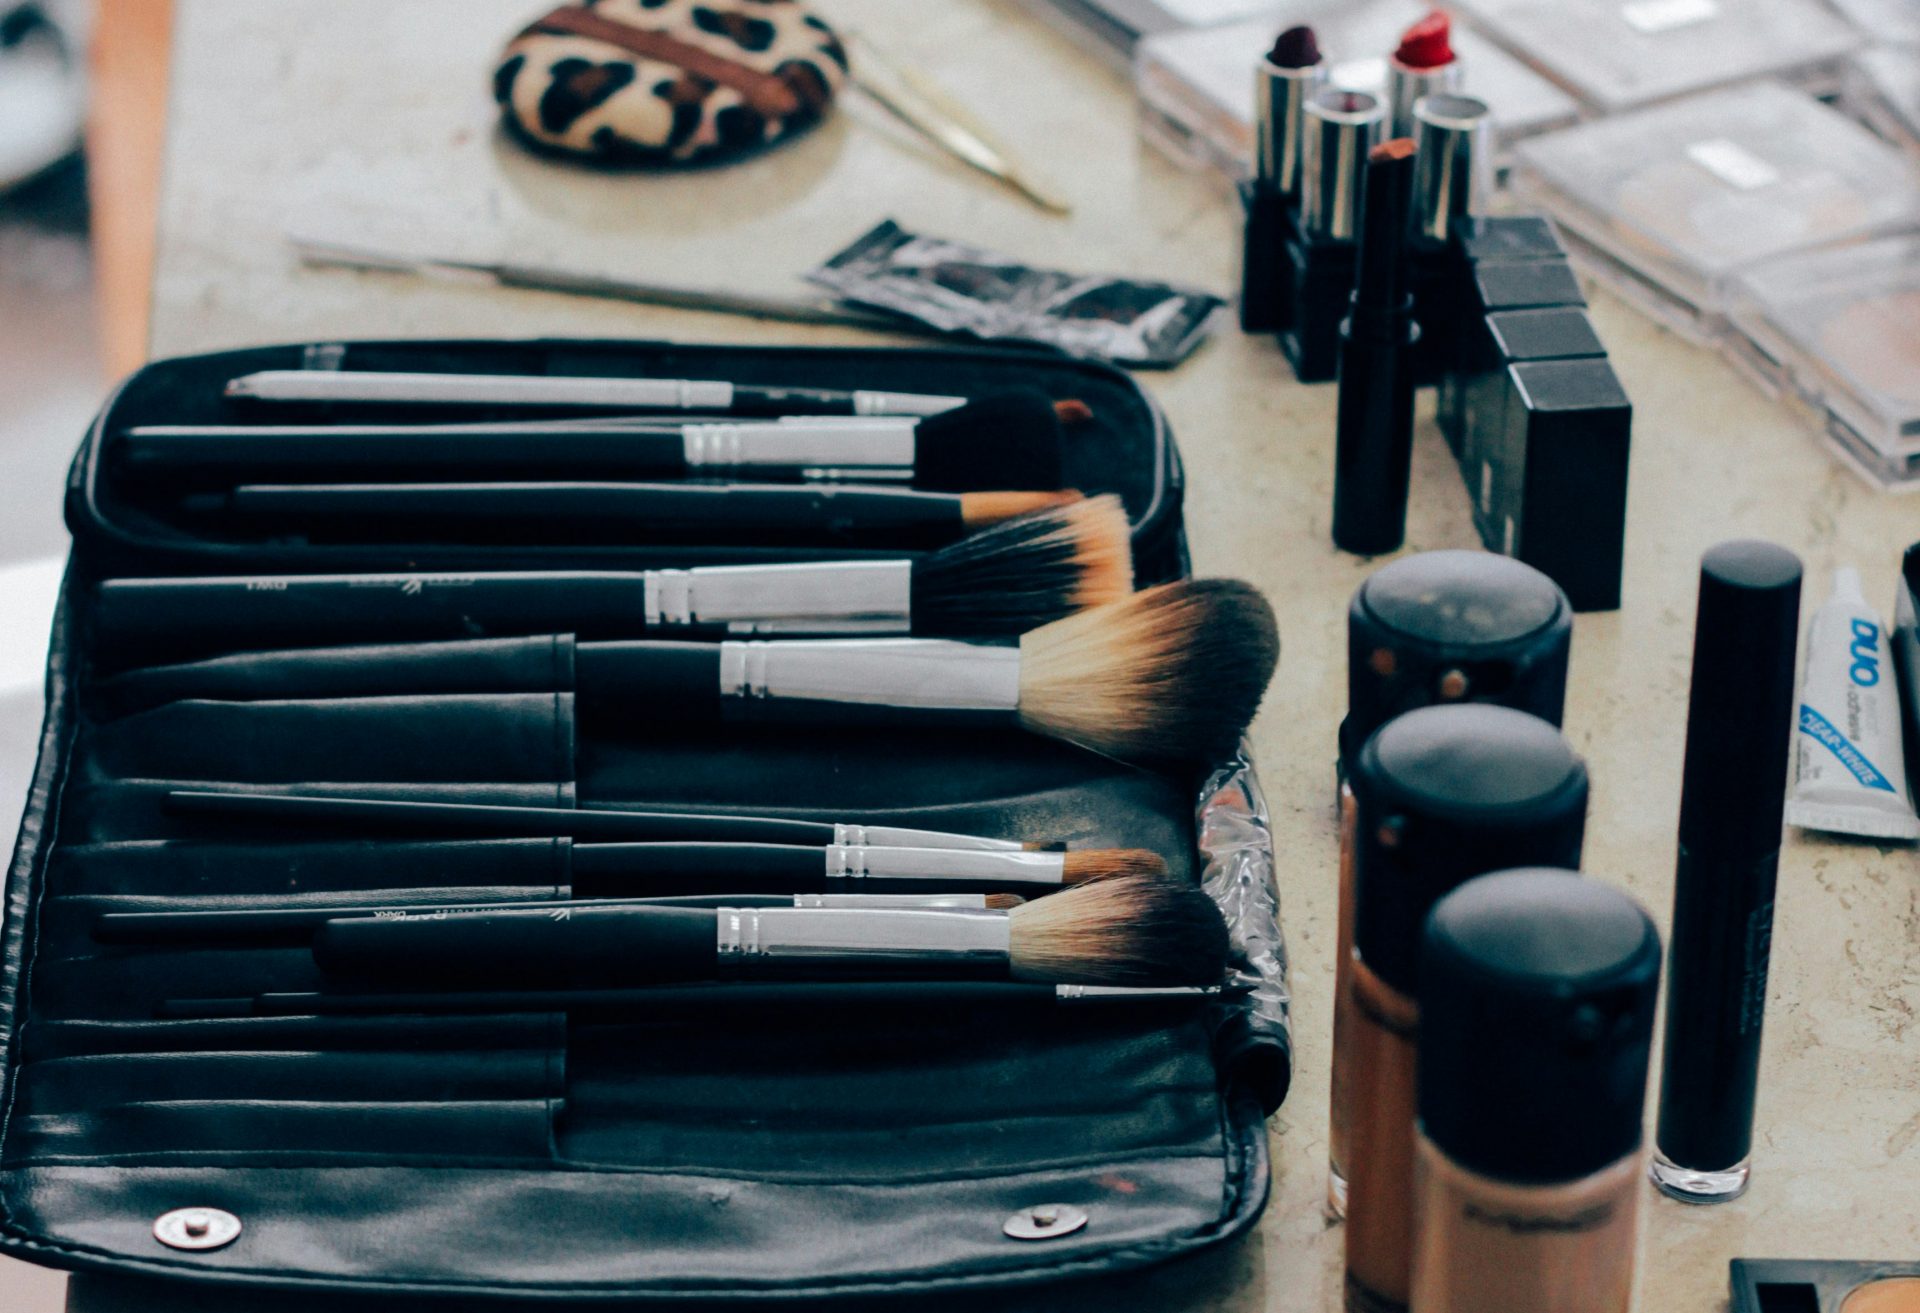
[{"left": 1008, "top": 875, "right": 1229, "bottom": 985}]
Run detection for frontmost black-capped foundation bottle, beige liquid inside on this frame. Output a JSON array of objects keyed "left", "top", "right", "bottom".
[{"left": 1411, "top": 870, "right": 1661, "bottom": 1313}]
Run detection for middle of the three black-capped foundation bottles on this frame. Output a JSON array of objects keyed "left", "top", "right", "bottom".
[{"left": 1334, "top": 706, "right": 1586, "bottom": 1313}]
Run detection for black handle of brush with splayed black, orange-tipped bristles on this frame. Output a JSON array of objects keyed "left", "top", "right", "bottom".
[{"left": 88, "top": 570, "right": 647, "bottom": 651}]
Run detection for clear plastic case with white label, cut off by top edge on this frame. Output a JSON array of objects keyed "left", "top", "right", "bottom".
[{"left": 1461, "top": 0, "right": 1860, "bottom": 113}]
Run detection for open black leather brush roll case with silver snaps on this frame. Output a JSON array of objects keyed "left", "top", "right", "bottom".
[{"left": 0, "top": 342, "right": 1290, "bottom": 1307}]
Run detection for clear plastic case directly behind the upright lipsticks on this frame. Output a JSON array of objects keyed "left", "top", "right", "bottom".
[{"left": 1135, "top": 0, "right": 1580, "bottom": 179}]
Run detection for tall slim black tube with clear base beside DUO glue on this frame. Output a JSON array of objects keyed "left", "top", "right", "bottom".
[{"left": 1651, "top": 541, "right": 1801, "bottom": 1204}]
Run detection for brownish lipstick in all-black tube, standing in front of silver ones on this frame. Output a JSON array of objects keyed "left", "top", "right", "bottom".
[{"left": 1332, "top": 136, "right": 1419, "bottom": 557}]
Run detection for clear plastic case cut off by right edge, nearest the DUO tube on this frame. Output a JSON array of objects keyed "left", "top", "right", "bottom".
[{"left": 1730, "top": 234, "right": 1920, "bottom": 489}]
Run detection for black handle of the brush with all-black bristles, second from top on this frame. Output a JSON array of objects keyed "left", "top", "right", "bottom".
[{"left": 115, "top": 424, "right": 687, "bottom": 484}]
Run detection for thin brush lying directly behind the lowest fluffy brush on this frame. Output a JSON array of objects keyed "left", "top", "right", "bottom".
[{"left": 92, "top": 893, "right": 1025, "bottom": 948}]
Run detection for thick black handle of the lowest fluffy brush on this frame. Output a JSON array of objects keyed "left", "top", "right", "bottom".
[{"left": 313, "top": 904, "right": 716, "bottom": 989}]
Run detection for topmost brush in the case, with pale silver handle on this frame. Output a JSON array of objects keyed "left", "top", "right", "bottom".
[{"left": 225, "top": 369, "right": 966, "bottom": 415}]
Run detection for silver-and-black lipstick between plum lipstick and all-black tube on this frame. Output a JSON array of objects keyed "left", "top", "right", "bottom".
[{"left": 1281, "top": 86, "right": 1386, "bottom": 382}]
